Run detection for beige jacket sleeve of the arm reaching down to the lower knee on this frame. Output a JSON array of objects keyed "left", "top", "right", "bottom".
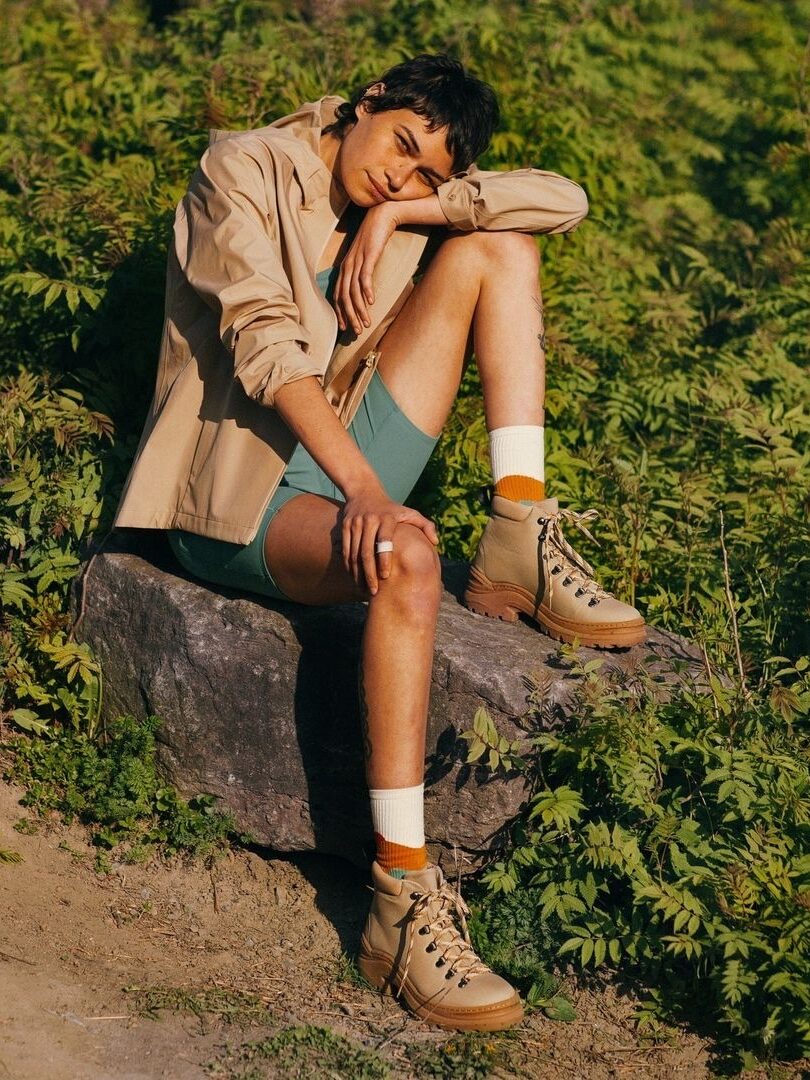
[{"left": 175, "top": 139, "right": 323, "bottom": 406}]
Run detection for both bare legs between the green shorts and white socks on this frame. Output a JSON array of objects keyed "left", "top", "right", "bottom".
[{"left": 265, "top": 232, "right": 544, "bottom": 787}]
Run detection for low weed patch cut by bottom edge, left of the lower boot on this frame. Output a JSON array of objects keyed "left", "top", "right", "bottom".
[{"left": 208, "top": 1024, "right": 391, "bottom": 1080}]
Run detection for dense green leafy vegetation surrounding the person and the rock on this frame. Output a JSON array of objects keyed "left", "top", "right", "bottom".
[{"left": 0, "top": 0, "right": 810, "bottom": 1063}]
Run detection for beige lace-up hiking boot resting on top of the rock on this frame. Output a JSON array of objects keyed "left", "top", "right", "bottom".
[{"left": 464, "top": 495, "right": 645, "bottom": 649}]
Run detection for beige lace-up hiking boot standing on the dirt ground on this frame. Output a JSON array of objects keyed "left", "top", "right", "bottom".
[{"left": 357, "top": 862, "right": 523, "bottom": 1031}]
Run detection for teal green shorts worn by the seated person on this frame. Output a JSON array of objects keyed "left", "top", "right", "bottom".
[{"left": 167, "top": 372, "right": 438, "bottom": 600}]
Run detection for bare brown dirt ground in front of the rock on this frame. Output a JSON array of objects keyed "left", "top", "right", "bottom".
[{"left": 0, "top": 784, "right": 773, "bottom": 1080}]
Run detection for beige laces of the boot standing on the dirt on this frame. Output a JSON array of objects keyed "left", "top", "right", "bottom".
[{"left": 396, "top": 881, "right": 489, "bottom": 998}]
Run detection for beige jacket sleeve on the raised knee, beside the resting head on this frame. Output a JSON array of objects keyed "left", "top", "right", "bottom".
[{"left": 437, "top": 165, "right": 588, "bottom": 233}]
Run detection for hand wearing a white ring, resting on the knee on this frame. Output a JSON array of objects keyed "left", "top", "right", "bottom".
[{"left": 341, "top": 485, "right": 438, "bottom": 596}]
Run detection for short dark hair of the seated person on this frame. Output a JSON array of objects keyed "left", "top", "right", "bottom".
[{"left": 324, "top": 53, "right": 500, "bottom": 172}]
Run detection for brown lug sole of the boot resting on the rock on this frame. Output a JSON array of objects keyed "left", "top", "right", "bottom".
[{"left": 463, "top": 566, "right": 647, "bottom": 649}]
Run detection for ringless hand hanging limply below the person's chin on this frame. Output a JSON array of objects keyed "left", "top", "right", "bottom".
[{"left": 335, "top": 202, "right": 399, "bottom": 335}]
